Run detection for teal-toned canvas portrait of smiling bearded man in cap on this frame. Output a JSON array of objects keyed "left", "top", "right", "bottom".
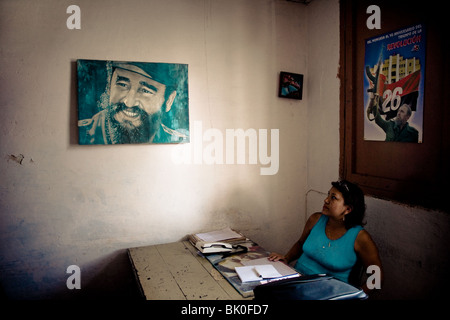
[{"left": 77, "top": 60, "right": 189, "bottom": 145}]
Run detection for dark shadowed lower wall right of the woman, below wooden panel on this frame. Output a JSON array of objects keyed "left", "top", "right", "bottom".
[{"left": 366, "top": 197, "right": 450, "bottom": 300}]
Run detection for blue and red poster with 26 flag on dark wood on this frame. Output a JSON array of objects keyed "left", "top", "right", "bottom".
[{"left": 364, "top": 24, "right": 426, "bottom": 143}]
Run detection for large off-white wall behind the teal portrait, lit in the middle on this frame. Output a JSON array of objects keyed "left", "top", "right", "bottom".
[{"left": 0, "top": 0, "right": 308, "bottom": 299}]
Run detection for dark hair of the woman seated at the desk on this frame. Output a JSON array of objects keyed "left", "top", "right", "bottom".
[{"left": 331, "top": 180, "right": 366, "bottom": 229}]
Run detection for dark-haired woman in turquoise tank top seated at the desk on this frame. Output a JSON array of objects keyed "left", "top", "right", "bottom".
[{"left": 269, "top": 180, "right": 383, "bottom": 293}]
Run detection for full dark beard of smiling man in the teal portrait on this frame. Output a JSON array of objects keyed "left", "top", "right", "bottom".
[{"left": 106, "top": 103, "right": 161, "bottom": 144}]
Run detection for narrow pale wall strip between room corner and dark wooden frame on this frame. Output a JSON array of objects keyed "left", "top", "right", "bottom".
[{"left": 308, "top": 1, "right": 340, "bottom": 194}]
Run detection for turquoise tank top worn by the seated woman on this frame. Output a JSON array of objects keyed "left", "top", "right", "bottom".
[{"left": 295, "top": 215, "right": 363, "bottom": 282}]
